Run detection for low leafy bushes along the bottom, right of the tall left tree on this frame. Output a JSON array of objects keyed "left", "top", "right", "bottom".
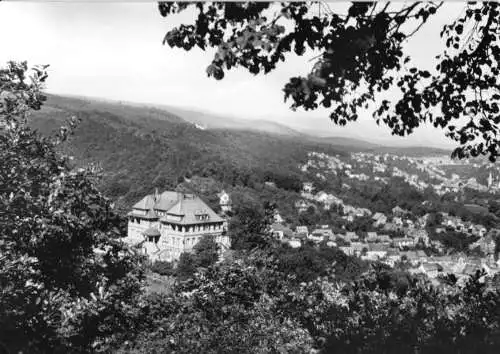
[{"left": 122, "top": 253, "right": 500, "bottom": 353}]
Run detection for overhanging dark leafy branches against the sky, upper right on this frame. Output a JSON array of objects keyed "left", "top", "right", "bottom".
[{"left": 159, "top": 2, "right": 500, "bottom": 161}]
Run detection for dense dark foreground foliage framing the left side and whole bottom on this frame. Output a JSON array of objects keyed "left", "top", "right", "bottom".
[{"left": 0, "top": 63, "right": 500, "bottom": 353}]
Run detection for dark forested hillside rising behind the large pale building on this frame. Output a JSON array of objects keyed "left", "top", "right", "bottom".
[{"left": 28, "top": 95, "right": 348, "bottom": 207}]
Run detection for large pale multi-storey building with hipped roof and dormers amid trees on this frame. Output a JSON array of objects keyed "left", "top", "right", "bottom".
[{"left": 125, "top": 191, "right": 230, "bottom": 261}]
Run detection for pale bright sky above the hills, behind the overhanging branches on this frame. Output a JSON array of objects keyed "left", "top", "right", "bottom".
[{"left": 0, "top": 1, "right": 463, "bottom": 147}]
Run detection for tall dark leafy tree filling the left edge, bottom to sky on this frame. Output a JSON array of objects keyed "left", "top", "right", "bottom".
[{"left": 0, "top": 63, "right": 143, "bottom": 353}]
